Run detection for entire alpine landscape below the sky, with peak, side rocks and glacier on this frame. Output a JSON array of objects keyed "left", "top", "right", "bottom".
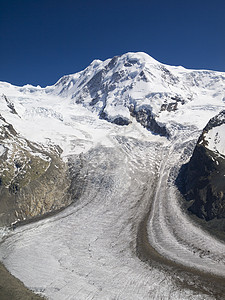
[{"left": 0, "top": 53, "right": 225, "bottom": 300}]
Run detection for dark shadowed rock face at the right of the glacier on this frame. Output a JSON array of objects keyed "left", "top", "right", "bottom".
[{"left": 179, "top": 111, "right": 225, "bottom": 221}]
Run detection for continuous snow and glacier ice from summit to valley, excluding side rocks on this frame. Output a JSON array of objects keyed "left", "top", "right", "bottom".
[{"left": 0, "top": 53, "right": 225, "bottom": 300}]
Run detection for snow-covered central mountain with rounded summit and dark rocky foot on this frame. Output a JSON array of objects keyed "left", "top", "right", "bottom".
[{"left": 46, "top": 53, "right": 225, "bottom": 135}]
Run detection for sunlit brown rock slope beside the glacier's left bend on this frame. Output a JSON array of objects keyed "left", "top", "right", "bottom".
[{"left": 0, "top": 117, "right": 77, "bottom": 226}]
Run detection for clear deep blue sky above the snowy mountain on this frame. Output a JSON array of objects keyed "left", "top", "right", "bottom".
[{"left": 0, "top": 0, "right": 225, "bottom": 86}]
